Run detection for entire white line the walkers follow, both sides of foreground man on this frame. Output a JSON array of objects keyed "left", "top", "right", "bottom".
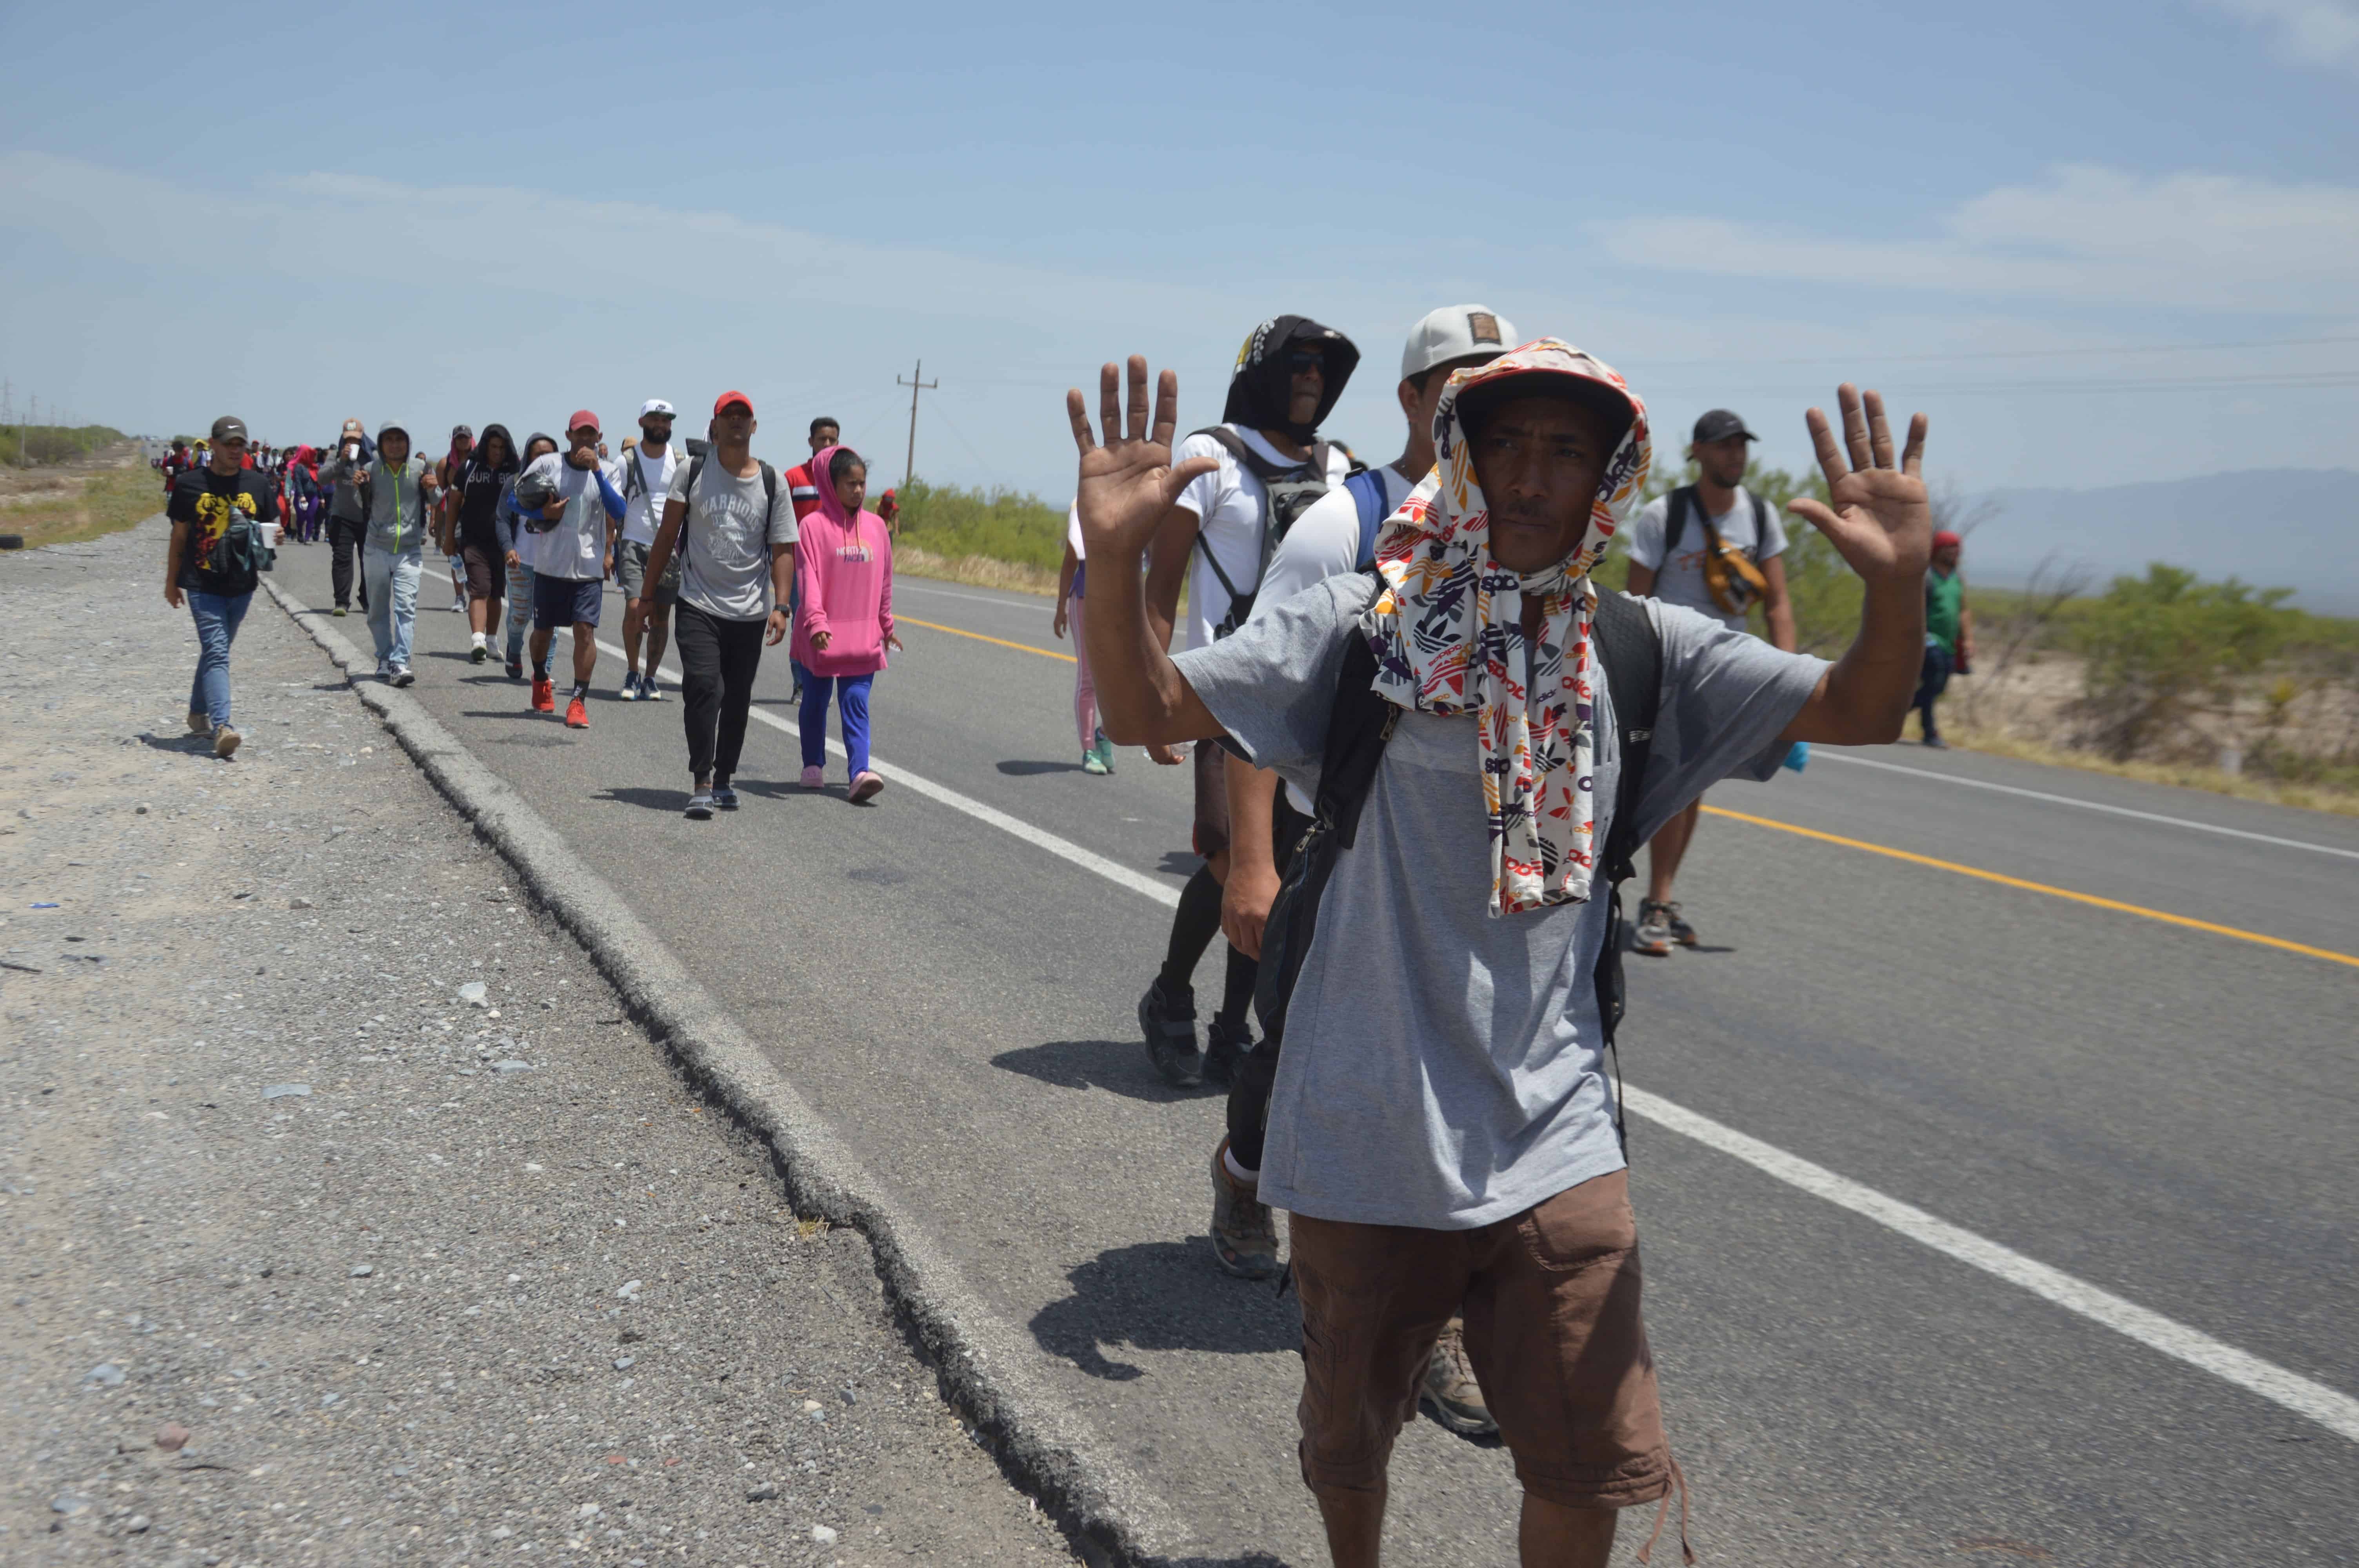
[{"left": 599, "top": 641, "right": 2359, "bottom": 1443}]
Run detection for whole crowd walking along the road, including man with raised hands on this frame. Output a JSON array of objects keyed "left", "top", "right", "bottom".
[{"left": 165, "top": 304, "right": 1944, "bottom": 1563}]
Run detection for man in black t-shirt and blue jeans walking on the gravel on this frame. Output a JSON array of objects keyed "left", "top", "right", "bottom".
[{"left": 163, "top": 415, "right": 278, "bottom": 757}]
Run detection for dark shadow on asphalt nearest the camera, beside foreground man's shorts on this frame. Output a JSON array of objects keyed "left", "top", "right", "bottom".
[{"left": 1031, "top": 1245, "right": 1302, "bottom": 1382}]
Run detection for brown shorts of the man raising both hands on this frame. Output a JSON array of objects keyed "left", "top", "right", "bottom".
[{"left": 1288, "top": 1172, "right": 1672, "bottom": 1509}]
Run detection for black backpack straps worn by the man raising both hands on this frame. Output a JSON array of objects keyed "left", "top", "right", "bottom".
[{"left": 1252, "top": 592, "right": 1663, "bottom": 1143}]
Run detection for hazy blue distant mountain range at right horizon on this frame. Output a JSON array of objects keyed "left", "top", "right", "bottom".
[{"left": 1965, "top": 469, "right": 2359, "bottom": 615}]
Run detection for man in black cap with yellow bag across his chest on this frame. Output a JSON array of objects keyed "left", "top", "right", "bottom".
[{"left": 1630, "top": 408, "right": 1795, "bottom": 957}]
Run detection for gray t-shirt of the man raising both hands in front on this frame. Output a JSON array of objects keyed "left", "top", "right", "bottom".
[{"left": 1175, "top": 573, "right": 1826, "bottom": 1231}]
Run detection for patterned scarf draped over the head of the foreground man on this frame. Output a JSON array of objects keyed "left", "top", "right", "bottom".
[{"left": 1361, "top": 337, "right": 1651, "bottom": 915}]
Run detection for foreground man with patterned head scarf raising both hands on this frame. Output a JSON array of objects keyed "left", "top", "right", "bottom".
[{"left": 1066, "top": 339, "right": 1932, "bottom": 1568}]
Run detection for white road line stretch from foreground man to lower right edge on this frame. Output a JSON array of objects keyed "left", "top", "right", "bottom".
[{"left": 1623, "top": 1089, "right": 2359, "bottom": 1443}]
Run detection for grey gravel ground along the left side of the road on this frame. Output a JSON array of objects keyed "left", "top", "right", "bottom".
[{"left": 0, "top": 521, "right": 1073, "bottom": 1566}]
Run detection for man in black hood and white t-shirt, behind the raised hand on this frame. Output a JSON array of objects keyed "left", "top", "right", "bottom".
[{"left": 1141, "top": 316, "right": 1359, "bottom": 1108}]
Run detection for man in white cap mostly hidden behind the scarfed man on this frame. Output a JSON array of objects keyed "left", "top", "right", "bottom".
[{"left": 1208, "top": 304, "right": 1517, "bottom": 1436}]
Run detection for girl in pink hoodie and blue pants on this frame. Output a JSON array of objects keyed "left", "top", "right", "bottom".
[{"left": 788, "top": 446, "right": 901, "bottom": 802}]
